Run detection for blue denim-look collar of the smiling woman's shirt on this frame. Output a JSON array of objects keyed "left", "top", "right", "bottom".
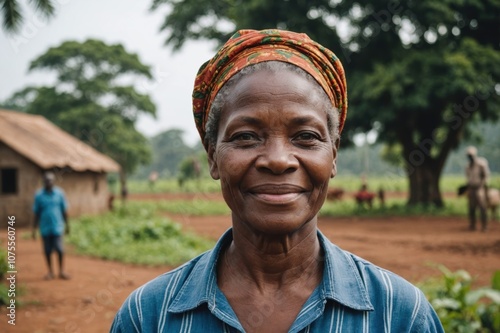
[{"left": 167, "top": 229, "right": 373, "bottom": 313}]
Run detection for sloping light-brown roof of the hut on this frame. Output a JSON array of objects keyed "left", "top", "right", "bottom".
[{"left": 0, "top": 109, "right": 120, "bottom": 172}]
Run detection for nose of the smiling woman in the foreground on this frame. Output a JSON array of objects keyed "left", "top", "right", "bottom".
[{"left": 255, "top": 139, "right": 299, "bottom": 174}]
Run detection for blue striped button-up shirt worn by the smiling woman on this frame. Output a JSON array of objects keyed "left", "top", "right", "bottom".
[{"left": 110, "top": 230, "right": 444, "bottom": 333}]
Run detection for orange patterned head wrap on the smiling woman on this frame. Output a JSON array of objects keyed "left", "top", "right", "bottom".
[{"left": 193, "top": 29, "right": 347, "bottom": 141}]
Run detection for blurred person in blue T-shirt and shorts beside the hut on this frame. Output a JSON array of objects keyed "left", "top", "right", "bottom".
[{"left": 33, "top": 172, "right": 70, "bottom": 280}]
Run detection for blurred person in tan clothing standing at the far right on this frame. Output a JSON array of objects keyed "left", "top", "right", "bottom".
[{"left": 465, "top": 146, "right": 490, "bottom": 231}]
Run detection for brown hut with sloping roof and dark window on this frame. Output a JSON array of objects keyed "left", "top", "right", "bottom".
[{"left": 0, "top": 109, "right": 120, "bottom": 228}]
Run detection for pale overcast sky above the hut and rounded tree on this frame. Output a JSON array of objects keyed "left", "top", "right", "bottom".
[{"left": 0, "top": 0, "right": 214, "bottom": 144}]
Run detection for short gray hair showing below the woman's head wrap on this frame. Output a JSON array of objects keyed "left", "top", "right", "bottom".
[{"left": 204, "top": 60, "right": 340, "bottom": 147}]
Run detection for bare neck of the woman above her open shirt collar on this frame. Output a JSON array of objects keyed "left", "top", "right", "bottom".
[{"left": 219, "top": 221, "right": 323, "bottom": 292}]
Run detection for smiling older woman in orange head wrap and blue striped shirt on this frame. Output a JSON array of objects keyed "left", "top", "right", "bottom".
[{"left": 111, "top": 30, "right": 443, "bottom": 333}]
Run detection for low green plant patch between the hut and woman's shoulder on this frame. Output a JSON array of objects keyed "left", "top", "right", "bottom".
[{"left": 68, "top": 202, "right": 213, "bottom": 265}]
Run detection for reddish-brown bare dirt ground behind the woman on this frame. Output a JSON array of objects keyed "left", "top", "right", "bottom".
[{"left": 0, "top": 195, "right": 500, "bottom": 333}]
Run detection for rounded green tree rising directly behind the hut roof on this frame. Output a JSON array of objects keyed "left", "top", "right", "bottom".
[{"left": 4, "top": 39, "right": 156, "bottom": 191}]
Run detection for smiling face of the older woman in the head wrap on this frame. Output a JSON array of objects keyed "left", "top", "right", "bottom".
[{"left": 209, "top": 71, "right": 337, "bottom": 235}]
